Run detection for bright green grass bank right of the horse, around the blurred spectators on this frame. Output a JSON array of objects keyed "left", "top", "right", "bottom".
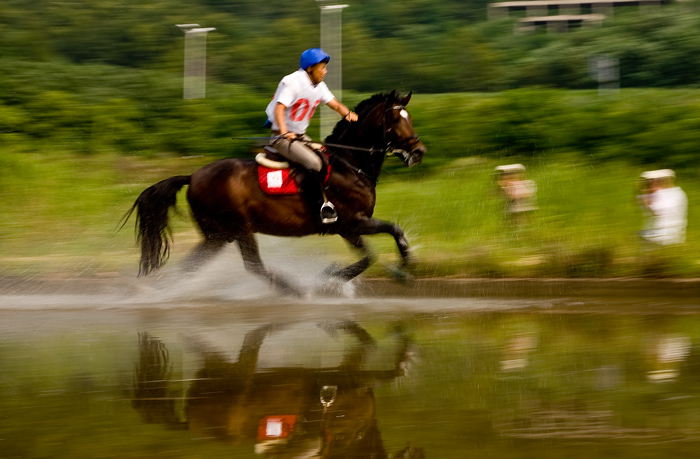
[{"left": 376, "top": 156, "right": 700, "bottom": 277}]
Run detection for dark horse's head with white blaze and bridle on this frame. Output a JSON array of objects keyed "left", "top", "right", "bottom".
[{"left": 382, "top": 91, "right": 426, "bottom": 167}]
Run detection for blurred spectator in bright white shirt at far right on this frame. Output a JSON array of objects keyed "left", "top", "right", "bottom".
[{"left": 640, "top": 169, "right": 688, "bottom": 245}]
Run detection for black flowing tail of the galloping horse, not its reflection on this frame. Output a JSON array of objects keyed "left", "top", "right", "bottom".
[{"left": 122, "top": 175, "right": 190, "bottom": 276}]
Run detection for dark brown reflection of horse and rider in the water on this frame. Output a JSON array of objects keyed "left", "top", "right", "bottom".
[{"left": 132, "top": 321, "right": 424, "bottom": 459}]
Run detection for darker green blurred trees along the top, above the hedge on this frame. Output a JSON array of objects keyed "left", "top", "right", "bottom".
[{"left": 0, "top": 0, "right": 700, "bottom": 94}]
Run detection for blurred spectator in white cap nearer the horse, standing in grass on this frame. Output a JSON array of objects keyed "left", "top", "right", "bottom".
[{"left": 496, "top": 164, "right": 537, "bottom": 225}]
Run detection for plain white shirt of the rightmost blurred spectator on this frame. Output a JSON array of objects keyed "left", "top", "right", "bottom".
[{"left": 647, "top": 187, "right": 688, "bottom": 245}]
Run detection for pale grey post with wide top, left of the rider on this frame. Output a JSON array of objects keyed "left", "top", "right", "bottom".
[{"left": 177, "top": 24, "right": 216, "bottom": 99}]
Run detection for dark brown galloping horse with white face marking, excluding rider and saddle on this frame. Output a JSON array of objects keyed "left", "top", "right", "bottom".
[{"left": 125, "top": 91, "right": 426, "bottom": 293}]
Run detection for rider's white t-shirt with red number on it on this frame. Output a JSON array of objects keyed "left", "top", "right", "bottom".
[{"left": 265, "top": 69, "right": 335, "bottom": 134}]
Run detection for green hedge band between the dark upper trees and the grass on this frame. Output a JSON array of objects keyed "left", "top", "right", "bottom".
[{"left": 0, "top": 72, "right": 700, "bottom": 168}]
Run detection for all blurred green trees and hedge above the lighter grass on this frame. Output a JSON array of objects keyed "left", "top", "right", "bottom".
[{"left": 0, "top": 0, "right": 700, "bottom": 167}]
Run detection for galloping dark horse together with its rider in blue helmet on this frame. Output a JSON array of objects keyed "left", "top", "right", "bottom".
[{"left": 124, "top": 48, "right": 426, "bottom": 294}]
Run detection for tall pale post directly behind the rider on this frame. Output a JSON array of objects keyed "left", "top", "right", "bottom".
[{"left": 316, "top": 0, "right": 349, "bottom": 139}]
